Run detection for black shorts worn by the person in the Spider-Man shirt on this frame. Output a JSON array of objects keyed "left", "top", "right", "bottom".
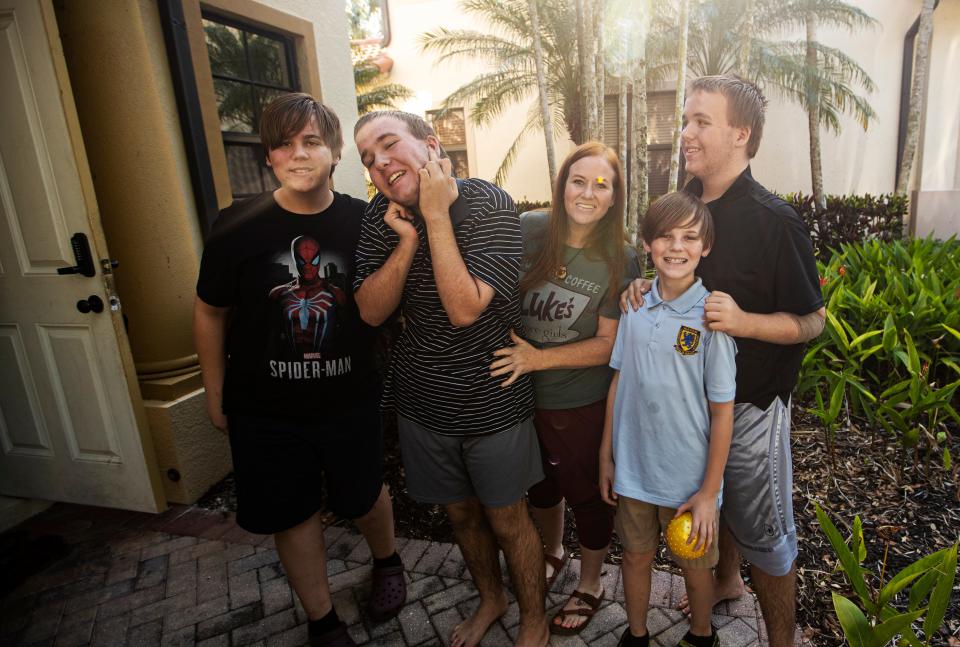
[{"left": 229, "top": 397, "right": 383, "bottom": 535}]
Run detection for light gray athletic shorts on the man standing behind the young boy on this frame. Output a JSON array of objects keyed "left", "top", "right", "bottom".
[{"left": 721, "top": 398, "right": 797, "bottom": 575}]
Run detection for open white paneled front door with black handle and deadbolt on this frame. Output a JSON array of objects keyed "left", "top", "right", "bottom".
[{"left": 0, "top": 0, "right": 165, "bottom": 512}]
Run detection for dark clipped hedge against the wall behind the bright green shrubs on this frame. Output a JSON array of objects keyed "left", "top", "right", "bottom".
[{"left": 783, "top": 193, "right": 909, "bottom": 262}]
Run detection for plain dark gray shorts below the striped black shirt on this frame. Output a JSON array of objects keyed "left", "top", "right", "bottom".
[{"left": 397, "top": 416, "right": 543, "bottom": 508}]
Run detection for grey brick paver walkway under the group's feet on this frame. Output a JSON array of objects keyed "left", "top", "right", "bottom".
[{"left": 0, "top": 504, "right": 804, "bottom": 647}]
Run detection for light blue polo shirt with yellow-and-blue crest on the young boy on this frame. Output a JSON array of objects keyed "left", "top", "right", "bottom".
[{"left": 610, "top": 279, "right": 737, "bottom": 508}]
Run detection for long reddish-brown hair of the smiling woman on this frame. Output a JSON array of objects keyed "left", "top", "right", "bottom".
[{"left": 520, "top": 142, "right": 626, "bottom": 296}]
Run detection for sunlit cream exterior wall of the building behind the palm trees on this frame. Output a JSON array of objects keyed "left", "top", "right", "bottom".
[{"left": 378, "top": 0, "right": 960, "bottom": 213}]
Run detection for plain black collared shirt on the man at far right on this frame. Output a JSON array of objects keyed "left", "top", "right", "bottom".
[{"left": 685, "top": 167, "right": 823, "bottom": 409}]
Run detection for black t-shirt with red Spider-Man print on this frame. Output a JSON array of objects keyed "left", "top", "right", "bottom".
[{"left": 197, "top": 192, "right": 378, "bottom": 420}]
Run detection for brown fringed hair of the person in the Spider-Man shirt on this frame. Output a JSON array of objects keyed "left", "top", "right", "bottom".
[{"left": 260, "top": 92, "right": 343, "bottom": 159}]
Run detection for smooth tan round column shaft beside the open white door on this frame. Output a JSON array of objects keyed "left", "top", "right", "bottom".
[{"left": 58, "top": 0, "right": 201, "bottom": 375}]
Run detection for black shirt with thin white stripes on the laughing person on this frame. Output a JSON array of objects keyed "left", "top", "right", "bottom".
[{"left": 354, "top": 179, "right": 533, "bottom": 436}]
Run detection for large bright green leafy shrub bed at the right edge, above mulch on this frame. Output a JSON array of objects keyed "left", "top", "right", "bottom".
[{"left": 798, "top": 238, "right": 960, "bottom": 468}]
